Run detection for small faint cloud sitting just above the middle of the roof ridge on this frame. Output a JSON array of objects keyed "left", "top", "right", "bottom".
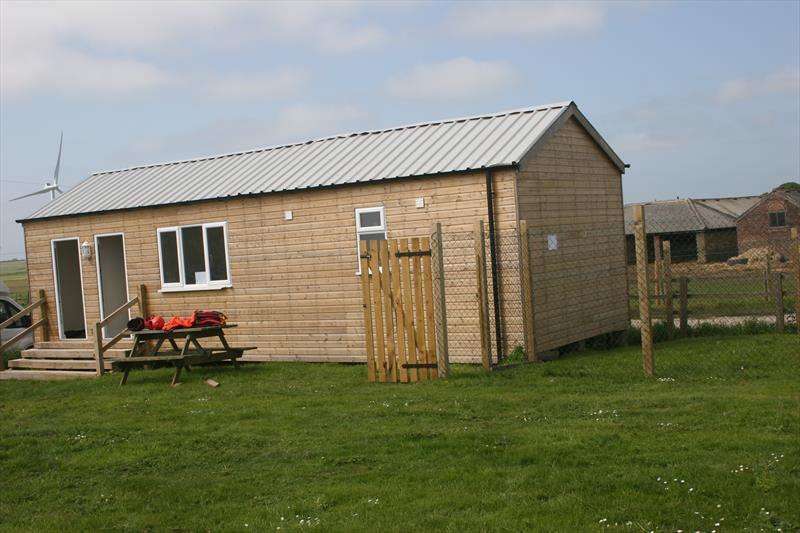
[{"left": 272, "top": 104, "right": 365, "bottom": 140}]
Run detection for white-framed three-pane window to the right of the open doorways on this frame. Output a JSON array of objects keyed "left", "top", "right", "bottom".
[{"left": 158, "top": 222, "right": 231, "bottom": 291}]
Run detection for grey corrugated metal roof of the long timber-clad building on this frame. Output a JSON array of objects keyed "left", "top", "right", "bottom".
[{"left": 18, "top": 102, "right": 624, "bottom": 220}]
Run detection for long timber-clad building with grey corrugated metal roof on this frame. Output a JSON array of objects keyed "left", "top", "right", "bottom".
[{"left": 7, "top": 102, "right": 628, "bottom": 374}]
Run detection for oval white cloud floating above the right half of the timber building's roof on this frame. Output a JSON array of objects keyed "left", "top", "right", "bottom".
[{"left": 389, "top": 57, "right": 518, "bottom": 99}]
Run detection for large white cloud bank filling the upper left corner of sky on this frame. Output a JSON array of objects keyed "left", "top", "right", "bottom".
[{"left": 0, "top": 0, "right": 387, "bottom": 96}]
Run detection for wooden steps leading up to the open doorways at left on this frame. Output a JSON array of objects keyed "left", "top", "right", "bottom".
[{"left": 0, "top": 340, "right": 130, "bottom": 380}]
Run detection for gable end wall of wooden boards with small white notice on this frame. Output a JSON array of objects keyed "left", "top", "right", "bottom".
[{"left": 517, "top": 119, "right": 628, "bottom": 351}]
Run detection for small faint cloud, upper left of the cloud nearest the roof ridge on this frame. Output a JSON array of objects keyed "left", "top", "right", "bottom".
[{"left": 208, "top": 68, "right": 308, "bottom": 99}]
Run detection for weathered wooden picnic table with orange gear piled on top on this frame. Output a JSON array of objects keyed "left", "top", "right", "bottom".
[{"left": 111, "top": 324, "right": 255, "bottom": 385}]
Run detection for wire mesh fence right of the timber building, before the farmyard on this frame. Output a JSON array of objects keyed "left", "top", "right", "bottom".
[{"left": 626, "top": 200, "right": 800, "bottom": 377}]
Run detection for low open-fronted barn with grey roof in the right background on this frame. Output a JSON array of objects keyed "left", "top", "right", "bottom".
[{"left": 625, "top": 196, "right": 759, "bottom": 264}]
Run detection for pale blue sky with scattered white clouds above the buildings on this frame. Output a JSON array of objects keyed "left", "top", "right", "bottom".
[{"left": 0, "top": 0, "right": 800, "bottom": 260}]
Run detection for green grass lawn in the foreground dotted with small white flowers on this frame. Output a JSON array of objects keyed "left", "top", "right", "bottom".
[{"left": 0, "top": 334, "right": 800, "bottom": 532}]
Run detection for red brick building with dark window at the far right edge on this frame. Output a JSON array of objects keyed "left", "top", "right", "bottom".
[{"left": 736, "top": 190, "right": 800, "bottom": 258}]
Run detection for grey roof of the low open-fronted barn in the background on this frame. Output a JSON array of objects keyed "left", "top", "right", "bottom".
[{"left": 625, "top": 196, "right": 760, "bottom": 235}]
